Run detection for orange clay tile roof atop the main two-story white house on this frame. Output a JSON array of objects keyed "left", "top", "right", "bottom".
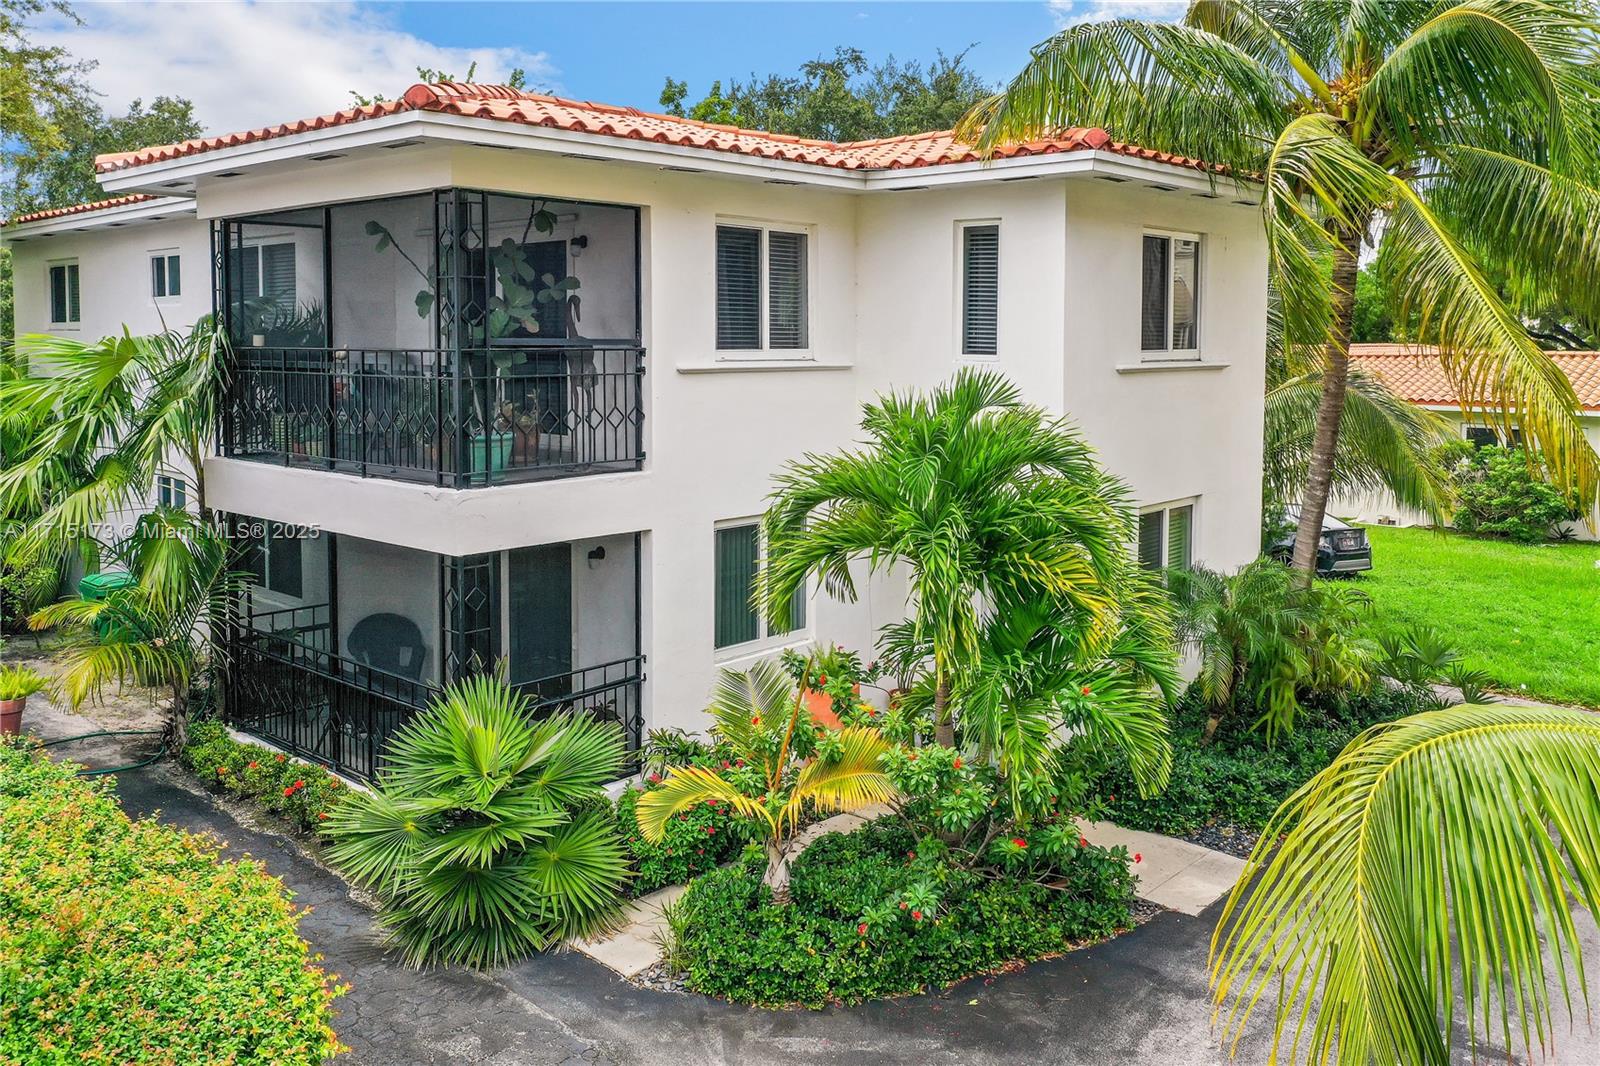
[{"left": 94, "top": 82, "right": 1205, "bottom": 173}]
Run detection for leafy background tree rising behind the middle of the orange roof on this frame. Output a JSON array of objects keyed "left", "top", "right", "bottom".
[{"left": 661, "top": 46, "right": 994, "bottom": 141}]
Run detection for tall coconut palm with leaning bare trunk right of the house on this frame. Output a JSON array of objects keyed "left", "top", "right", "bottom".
[{"left": 958, "top": 0, "right": 1600, "bottom": 584}]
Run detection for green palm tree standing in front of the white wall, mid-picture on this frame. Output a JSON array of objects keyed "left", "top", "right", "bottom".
[{"left": 757, "top": 368, "right": 1138, "bottom": 747}]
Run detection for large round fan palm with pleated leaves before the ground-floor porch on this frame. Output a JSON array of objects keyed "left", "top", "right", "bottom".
[{"left": 325, "top": 675, "right": 627, "bottom": 967}]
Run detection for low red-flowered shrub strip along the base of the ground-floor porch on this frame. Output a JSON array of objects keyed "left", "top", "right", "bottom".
[{"left": 181, "top": 722, "right": 349, "bottom": 832}]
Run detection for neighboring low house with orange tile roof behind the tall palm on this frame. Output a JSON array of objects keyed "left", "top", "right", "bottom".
[{"left": 1328, "top": 344, "right": 1600, "bottom": 541}]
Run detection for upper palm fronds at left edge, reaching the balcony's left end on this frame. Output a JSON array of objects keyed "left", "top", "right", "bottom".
[{"left": 0, "top": 317, "right": 226, "bottom": 562}]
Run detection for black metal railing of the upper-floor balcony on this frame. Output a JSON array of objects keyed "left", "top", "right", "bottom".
[{"left": 222, "top": 346, "right": 645, "bottom": 487}]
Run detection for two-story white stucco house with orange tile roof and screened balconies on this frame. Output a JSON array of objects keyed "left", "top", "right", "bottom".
[{"left": 6, "top": 85, "right": 1266, "bottom": 773}]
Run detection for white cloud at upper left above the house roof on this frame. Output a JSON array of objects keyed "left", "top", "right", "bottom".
[{"left": 37, "top": 3, "right": 558, "bottom": 133}]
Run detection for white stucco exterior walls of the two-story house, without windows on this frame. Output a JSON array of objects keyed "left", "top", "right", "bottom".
[{"left": 9, "top": 147, "right": 1266, "bottom": 739}]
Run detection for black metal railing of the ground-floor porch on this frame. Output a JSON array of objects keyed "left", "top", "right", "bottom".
[{"left": 226, "top": 624, "right": 643, "bottom": 781}]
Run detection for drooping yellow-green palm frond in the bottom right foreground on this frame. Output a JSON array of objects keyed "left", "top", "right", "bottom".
[{"left": 1210, "top": 706, "right": 1600, "bottom": 1066}]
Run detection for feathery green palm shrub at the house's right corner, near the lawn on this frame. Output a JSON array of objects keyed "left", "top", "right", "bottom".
[{"left": 1168, "top": 559, "right": 1373, "bottom": 743}]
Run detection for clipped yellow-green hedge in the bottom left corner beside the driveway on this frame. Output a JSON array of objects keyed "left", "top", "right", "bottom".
[{"left": 0, "top": 741, "right": 344, "bottom": 1064}]
